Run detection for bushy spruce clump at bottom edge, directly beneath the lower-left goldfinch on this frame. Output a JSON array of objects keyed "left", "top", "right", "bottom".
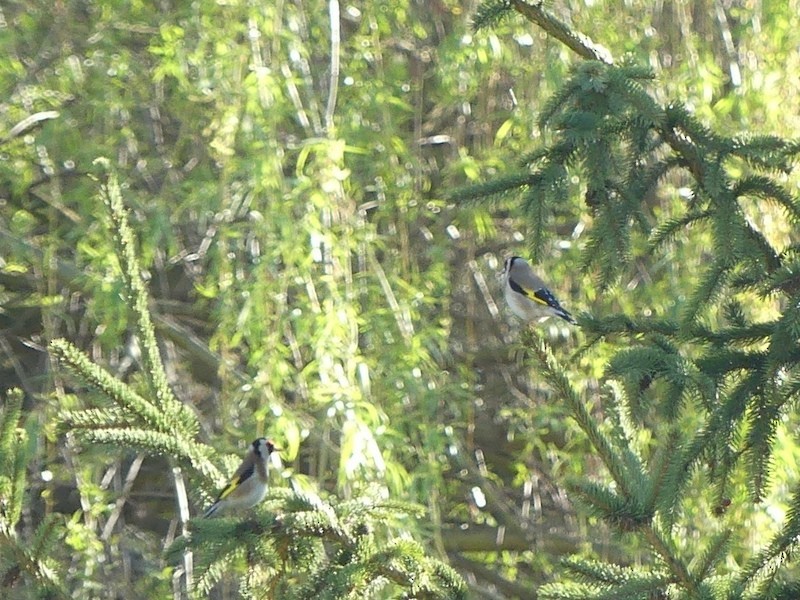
[{"left": 168, "top": 489, "right": 466, "bottom": 600}]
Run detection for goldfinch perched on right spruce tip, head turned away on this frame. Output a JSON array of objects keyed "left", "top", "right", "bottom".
[{"left": 503, "top": 256, "right": 577, "bottom": 325}]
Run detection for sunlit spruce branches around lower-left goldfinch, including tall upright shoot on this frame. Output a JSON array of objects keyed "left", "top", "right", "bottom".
[{"left": 43, "top": 175, "right": 465, "bottom": 598}]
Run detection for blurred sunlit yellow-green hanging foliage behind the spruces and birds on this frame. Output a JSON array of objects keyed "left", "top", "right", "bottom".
[{"left": 0, "top": 0, "right": 800, "bottom": 598}]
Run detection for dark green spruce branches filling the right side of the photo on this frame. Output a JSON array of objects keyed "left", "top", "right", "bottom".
[{"left": 462, "top": 0, "right": 800, "bottom": 598}]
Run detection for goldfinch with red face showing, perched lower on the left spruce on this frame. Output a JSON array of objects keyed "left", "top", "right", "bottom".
[{"left": 203, "top": 438, "right": 278, "bottom": 517}]
